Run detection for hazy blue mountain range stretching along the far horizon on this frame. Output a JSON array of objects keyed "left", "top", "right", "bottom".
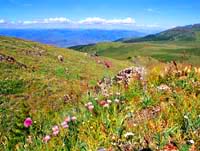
[{"left": 0, "top": 29, "right": 145, "bottom": 47}]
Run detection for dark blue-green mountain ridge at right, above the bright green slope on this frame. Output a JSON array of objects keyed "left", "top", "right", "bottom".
[{"left": 116, "top": 24, "right": 200, "bottom": 43}]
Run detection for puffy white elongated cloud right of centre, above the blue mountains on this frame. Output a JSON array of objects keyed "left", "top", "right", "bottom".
[{"left": 78, "top": 17, "right": 135, "bottom": 25}]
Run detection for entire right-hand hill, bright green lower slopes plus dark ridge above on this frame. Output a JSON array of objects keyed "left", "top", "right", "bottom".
[{"left": 71, "top": 24, "right": 200, "bottom": 65}]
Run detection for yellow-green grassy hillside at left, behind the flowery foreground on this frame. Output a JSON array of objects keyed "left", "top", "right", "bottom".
[{"left": 0, "top": 37, "right": 131, "bottom": 149}]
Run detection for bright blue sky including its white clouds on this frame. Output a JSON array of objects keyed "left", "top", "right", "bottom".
[{"left": 0, "top": 0, "right": 200, "bottom": 30}]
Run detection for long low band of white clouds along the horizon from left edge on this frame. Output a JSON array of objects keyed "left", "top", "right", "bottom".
[{"left": 0, "top": 17, "right": 162, "bottom": 30}]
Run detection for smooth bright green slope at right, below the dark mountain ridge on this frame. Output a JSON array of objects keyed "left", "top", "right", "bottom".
[{"left": 74, "top": 41, "right": 200, "bottom": 65}]
